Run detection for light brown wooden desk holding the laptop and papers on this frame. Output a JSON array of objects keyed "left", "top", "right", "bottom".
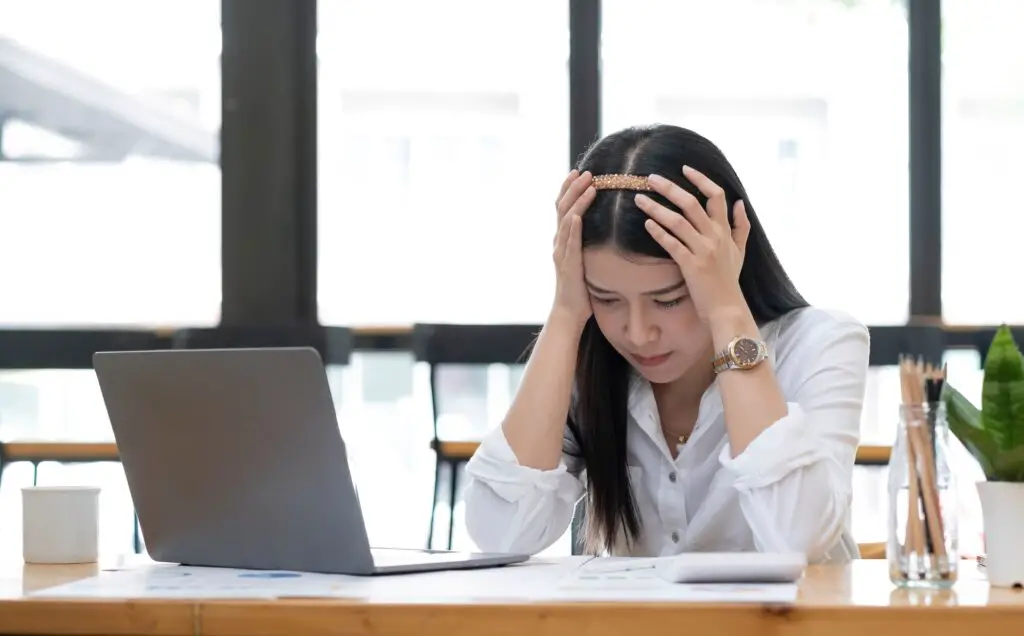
[{"left": 0, "top": 561, "right": 1024, "bottom": 636}]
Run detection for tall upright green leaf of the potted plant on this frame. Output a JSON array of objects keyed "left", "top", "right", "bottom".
[{"left": 981, "top": 325, "right": 1024, "bottom": 448}]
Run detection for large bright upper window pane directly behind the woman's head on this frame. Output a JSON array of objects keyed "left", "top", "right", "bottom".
[{"left": 601, "top": 0, "right": 908, "bottom": 325}]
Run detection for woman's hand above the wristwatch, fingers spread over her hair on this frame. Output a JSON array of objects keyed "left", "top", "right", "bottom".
[{"left": 636, "top": 166, "right": 751, "bottom": 323}]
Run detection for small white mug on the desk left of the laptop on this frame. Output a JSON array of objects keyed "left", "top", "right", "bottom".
[{"left": 22, "top": 485, "right": 99, "bottom": 563}]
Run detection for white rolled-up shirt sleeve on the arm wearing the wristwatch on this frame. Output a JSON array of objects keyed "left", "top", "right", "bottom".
[{"left": 719, "top": 319, "right": 870, "bottom": 561}]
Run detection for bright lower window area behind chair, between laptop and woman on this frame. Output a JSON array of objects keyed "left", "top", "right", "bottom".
[{"left": 328, "top": 351, "right": 571, "bottom": 555}]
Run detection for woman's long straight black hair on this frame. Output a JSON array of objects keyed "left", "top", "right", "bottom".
[{"left": 568, "top": 125, "right": 807, "bottom": 552}]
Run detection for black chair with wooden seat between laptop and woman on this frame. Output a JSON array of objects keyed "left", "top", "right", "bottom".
[{"left": 413, "top": 324, "right": 541, "bottom": 549}]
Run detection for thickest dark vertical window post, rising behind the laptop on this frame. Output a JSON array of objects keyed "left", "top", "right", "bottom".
[{"left": 221, "top": 0, "right": 317, "bottom": 328}]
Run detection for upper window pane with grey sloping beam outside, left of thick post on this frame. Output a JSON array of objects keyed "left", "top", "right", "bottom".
[{"left": 0, "top": 0, "right": 220, "bottom": 326}]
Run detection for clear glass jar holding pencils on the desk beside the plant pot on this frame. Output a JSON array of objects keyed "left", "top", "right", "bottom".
[{"left": 886, "top": 402, "right": 959, "bottom": 588}]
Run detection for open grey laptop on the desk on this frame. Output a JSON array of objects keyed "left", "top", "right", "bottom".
[{"left": 93, "top": 347, "right": 528, "bottom": 575}]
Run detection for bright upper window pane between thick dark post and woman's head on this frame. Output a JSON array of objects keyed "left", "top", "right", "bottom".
[{"left": 318, "top": 0, "right": 568, "bottom": 325}]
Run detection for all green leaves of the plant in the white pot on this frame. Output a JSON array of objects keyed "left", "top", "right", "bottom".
[{"left": 944, "top": 325, "right": 1024, "bottom": 481}]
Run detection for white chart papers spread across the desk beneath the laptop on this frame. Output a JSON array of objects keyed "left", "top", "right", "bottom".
[{"left": 31, "top": 557, "right": 797, "bottom": 603}]
